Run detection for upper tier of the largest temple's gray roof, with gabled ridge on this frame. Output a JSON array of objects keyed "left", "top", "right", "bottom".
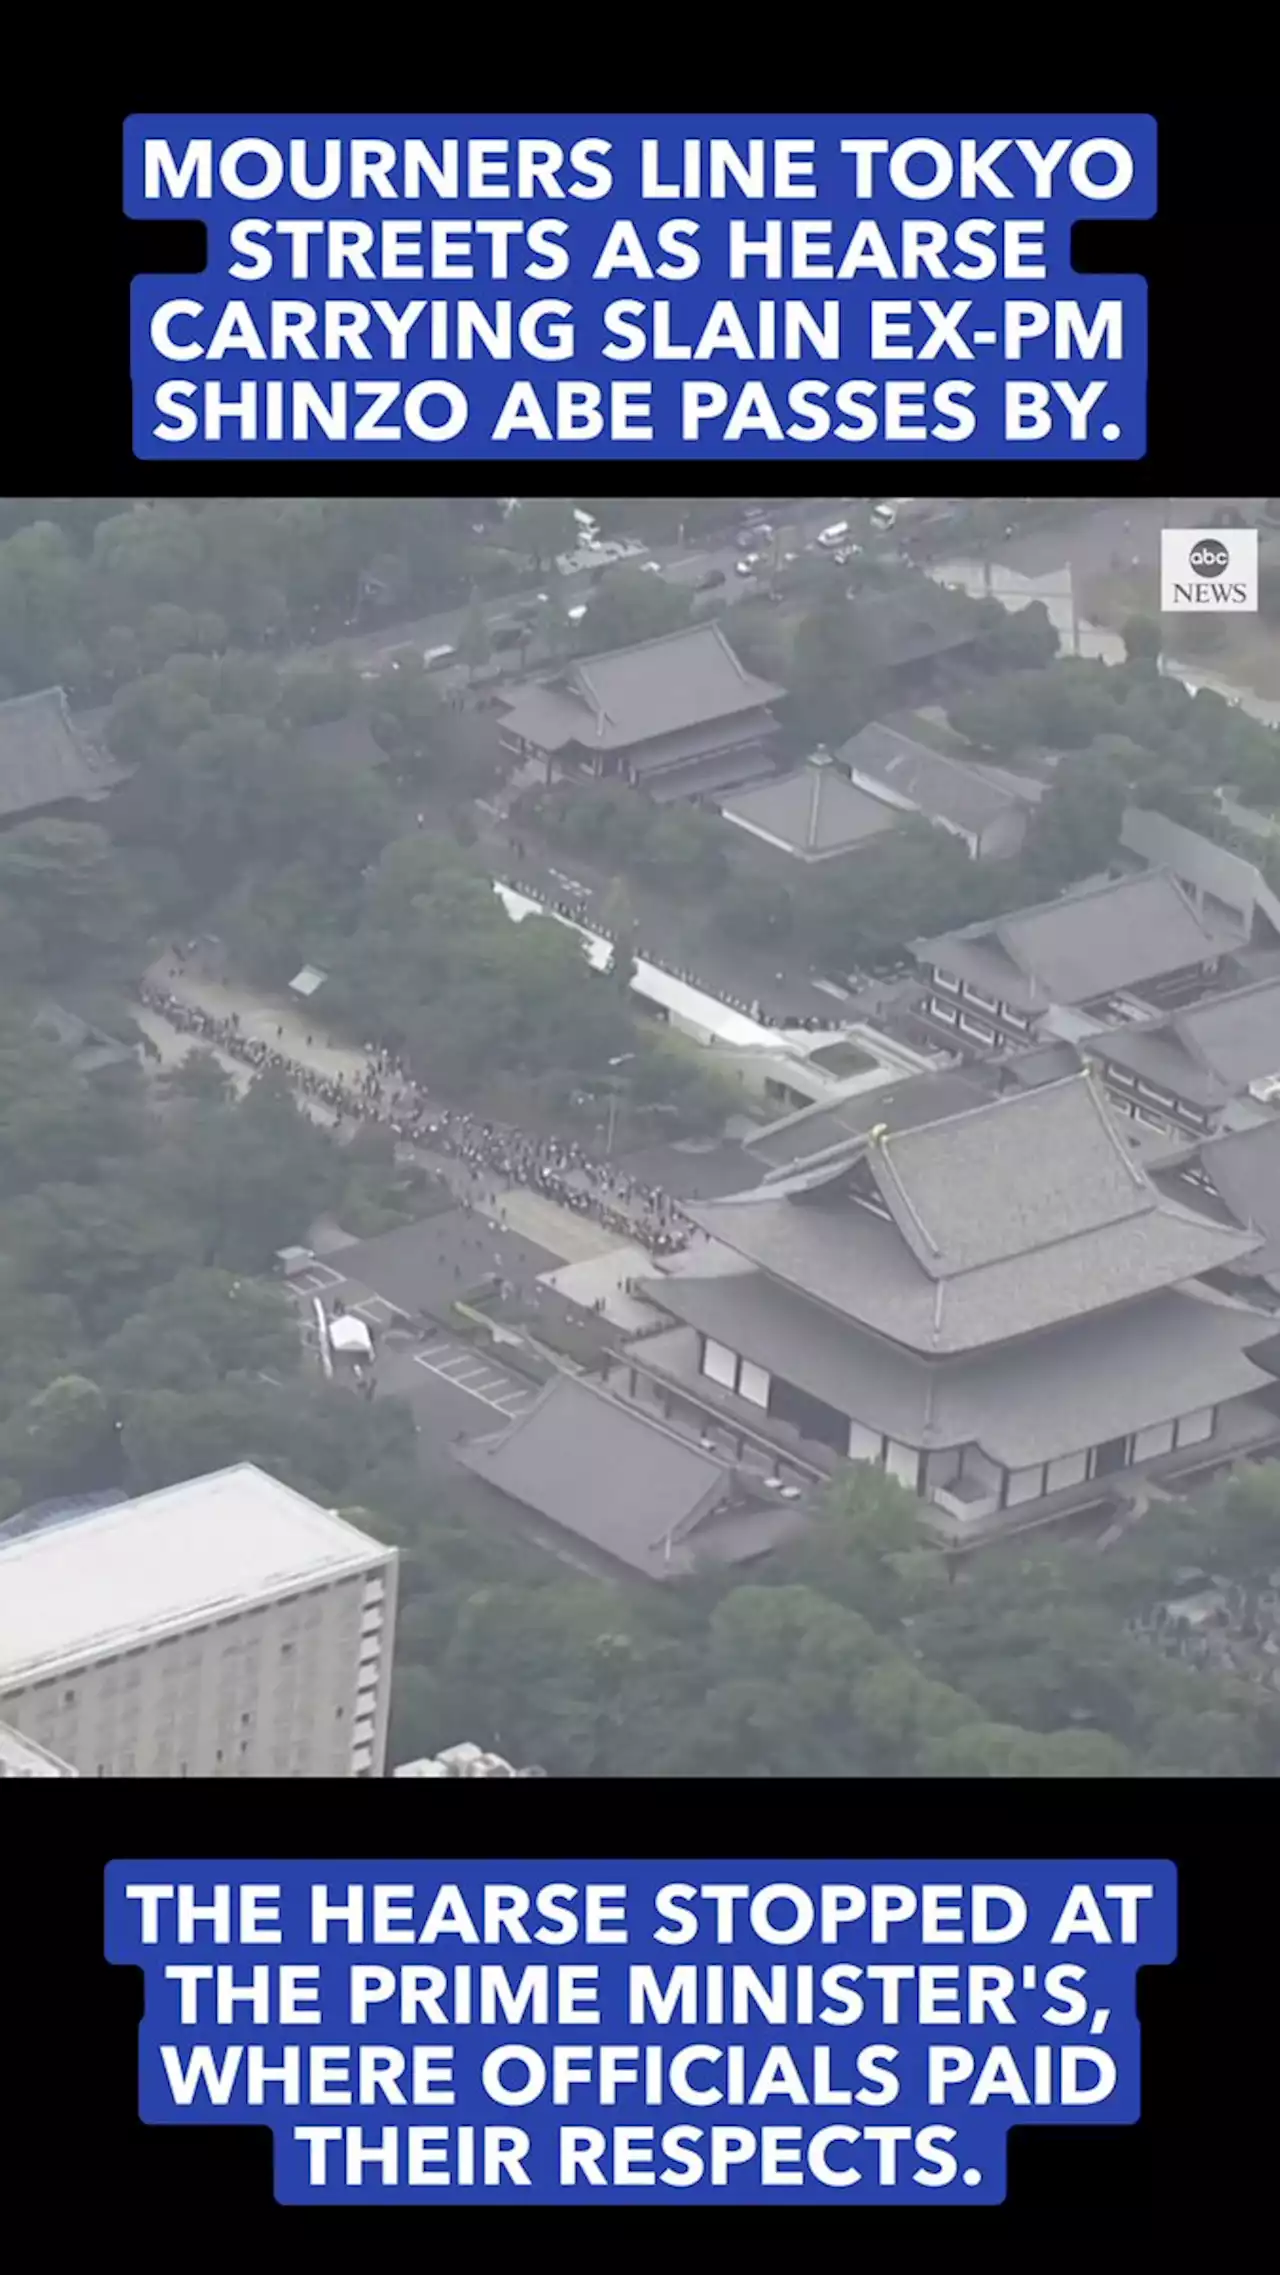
[{"left": 687, "top": 1076, "right": 1257, "bottom": 1354}]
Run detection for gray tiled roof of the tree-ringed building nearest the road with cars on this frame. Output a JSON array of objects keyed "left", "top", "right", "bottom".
[{"left": 502, "top": 623, "right": 784, "bottom": 751}]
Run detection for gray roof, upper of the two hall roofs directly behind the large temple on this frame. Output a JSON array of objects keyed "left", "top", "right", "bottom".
[{"left": 912, "top": 869, "right": 1244, "bottom": 1010}]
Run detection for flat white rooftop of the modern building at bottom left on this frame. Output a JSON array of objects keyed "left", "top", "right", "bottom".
[{"left": 0, "top": 1463, "right": 389, "bottom": 1693}]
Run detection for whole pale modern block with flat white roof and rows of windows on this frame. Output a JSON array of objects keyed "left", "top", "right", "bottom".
[{"left": 0, "top": 1463, "right": 396, "bottom": 1777}]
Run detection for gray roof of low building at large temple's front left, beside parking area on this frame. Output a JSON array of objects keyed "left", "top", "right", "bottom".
[{"left": 452, "top": 1376, "right": 732, "bottom": 1579}]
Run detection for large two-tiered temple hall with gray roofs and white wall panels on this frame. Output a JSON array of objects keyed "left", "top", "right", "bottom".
[{"left": 625, "top": 1074, "right": 1280, "bottom": 1540}]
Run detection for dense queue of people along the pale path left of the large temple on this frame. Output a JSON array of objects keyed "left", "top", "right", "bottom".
[{"left": 139, "top": 983, "right": 693, "bottom": 1256}]
